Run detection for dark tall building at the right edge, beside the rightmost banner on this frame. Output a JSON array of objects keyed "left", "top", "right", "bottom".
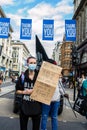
[{"left": 73, "top": 0, "right": 87, "bottom": 75}]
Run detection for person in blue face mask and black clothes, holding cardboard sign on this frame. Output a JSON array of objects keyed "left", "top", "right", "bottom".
[{"left": 16, "top": 56, "right": 41, "bottom": 130}]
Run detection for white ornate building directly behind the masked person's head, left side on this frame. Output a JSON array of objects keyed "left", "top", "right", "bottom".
[{"left": 11, "top": 40, "right": 30, "bottom": 75}]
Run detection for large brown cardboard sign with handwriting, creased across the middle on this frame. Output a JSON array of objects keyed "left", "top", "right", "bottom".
[{"left": 30, "top": 61, "right": 62, "bottom": 105}]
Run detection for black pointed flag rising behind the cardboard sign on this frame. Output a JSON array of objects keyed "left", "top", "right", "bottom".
[{"left": 36, "top": 35, "right": 48, "bottom": 70}]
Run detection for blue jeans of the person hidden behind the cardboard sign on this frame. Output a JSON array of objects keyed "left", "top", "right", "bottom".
[{"left": 41, "top": 101, "right": 60, "bottom": 130}]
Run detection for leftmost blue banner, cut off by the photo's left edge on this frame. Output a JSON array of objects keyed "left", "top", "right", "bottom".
[{"left": 0, "top": 18, "right": 10, "bottom": 38}]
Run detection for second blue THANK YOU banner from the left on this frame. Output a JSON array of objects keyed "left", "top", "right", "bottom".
[{"left": 20, "top": 19, "right": 32, "bottom": 40}]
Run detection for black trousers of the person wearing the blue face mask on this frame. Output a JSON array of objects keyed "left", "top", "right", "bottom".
[{"left": 20, "top": 111, "right": 41, "bottom": 130}]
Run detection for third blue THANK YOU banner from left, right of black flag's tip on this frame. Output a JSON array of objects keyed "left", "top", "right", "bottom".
[{"left": 42, "top": 20, "right": 54, "bottom": 40}]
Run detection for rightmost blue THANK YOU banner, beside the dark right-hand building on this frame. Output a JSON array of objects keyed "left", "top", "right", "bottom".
[{"left": 65, "top": 20, "right": 76, "bottom": 41}]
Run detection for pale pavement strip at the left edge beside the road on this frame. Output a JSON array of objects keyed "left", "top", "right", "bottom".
[{"left": 0, "top": 78, "right": 15, "bottom": 97}]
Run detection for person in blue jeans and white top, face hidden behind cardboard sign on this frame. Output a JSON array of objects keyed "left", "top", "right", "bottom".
[{"left": 41, "top": 59, "right": 68, "bottom": 130}]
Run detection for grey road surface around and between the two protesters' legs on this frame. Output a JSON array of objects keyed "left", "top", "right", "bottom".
[{"left": 0, "top": 82, "right": 87, "bottom": 130}]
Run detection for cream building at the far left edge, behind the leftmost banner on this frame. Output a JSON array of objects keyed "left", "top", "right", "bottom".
[{"left": 0, "top": 6, "right": 13, "bottom": 77}]
